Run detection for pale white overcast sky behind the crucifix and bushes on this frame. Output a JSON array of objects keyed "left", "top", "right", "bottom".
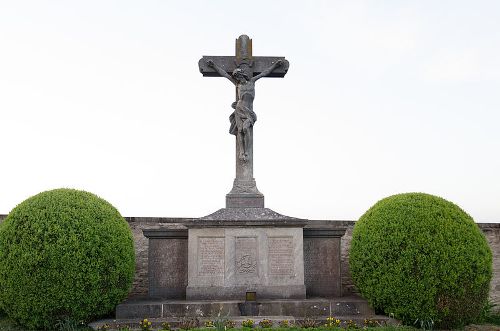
[{"left": 0, "top": 0, "right": 500, "bottom": 222}]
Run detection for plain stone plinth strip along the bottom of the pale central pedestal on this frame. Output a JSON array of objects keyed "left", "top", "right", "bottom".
[{"left": 186, "top": 285, "right": 306, "bottom": 301}]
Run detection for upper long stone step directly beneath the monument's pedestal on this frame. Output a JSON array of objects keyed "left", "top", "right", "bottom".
[{"left": 116, "top": 296, "right": 375, "bottom": 319}]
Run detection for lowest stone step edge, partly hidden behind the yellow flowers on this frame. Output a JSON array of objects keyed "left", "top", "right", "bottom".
[{"left": 89, "top": 315, "right": 399, "bottom": 330}]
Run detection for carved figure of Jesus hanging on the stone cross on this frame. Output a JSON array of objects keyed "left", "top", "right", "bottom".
[{"left": 207, "top": 60, "right": 283, "bottom": 162}]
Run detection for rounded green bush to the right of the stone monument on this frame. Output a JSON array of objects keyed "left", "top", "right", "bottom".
[{"left": 349, "top": 193, "right": 492, "bottom": 328}]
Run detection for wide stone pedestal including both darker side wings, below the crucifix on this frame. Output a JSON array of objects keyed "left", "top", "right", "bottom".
[{"left": 137, "top": 218, "right": 346, "bottom": 302}]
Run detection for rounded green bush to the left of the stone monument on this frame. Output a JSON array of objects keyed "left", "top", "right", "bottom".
[{"left": 0, "top": 189, "right": 135, "bottom": 330}]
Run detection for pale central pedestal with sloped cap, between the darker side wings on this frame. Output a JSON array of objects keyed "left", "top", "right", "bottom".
[{"left": 185, "top": 208, "right": 307, "bottom": 300}]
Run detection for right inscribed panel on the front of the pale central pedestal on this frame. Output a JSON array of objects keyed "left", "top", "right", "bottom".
[{"left": 268, "top": 237, "right": 294, "bottom": 276}]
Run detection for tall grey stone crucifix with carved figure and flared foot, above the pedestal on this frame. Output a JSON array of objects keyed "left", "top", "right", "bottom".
[{"left": 198, "top": 35, "right": 289, "bottom": 208}]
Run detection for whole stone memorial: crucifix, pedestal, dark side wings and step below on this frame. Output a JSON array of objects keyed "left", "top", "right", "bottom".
[{"left": 116, "top": 35, "right": 348, "bottom": 318}]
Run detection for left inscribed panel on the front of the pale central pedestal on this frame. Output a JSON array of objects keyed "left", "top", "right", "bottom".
[{"left": 198, "top": 237, "right": 224, "bottom": 276}]
